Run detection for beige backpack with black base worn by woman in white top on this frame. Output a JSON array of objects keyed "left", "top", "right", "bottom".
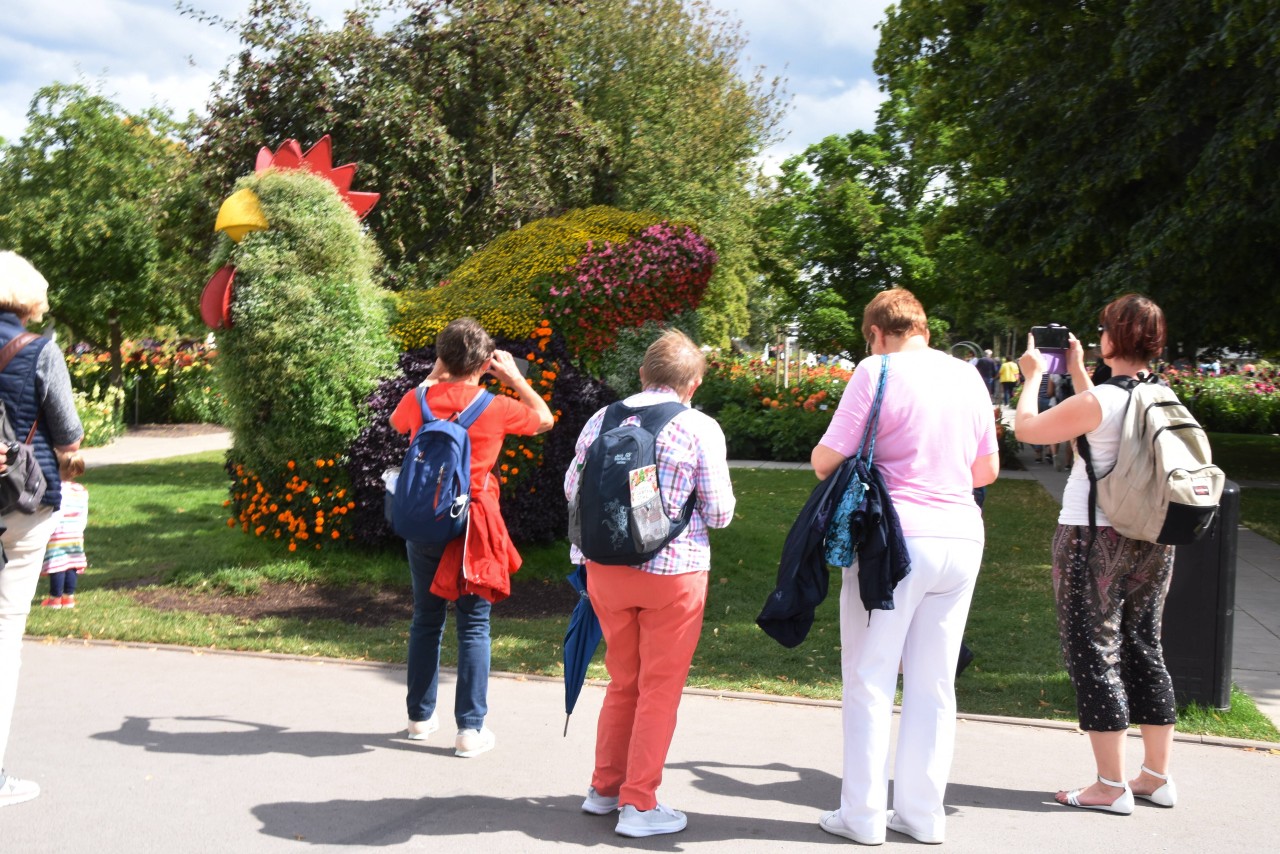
[{"left": 1076, "top": 376, "right": 1226, "bottom": 545}]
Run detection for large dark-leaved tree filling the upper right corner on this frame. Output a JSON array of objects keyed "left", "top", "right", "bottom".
[{"left": 877, "top": 0, "right": 1280, "bottom": 351}]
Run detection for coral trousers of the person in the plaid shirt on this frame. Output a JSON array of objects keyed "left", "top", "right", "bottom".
[{"left": 586, "top": 562, "right": 708, "bottom": 810}]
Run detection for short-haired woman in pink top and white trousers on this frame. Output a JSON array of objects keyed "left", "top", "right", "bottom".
[{"left": 812, "top": 288, "right": 1000, "bottom": 845}]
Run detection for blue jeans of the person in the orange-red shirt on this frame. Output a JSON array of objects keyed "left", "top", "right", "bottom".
[{"left": 406, "top": 543, "right": 493, "bottom": 730}]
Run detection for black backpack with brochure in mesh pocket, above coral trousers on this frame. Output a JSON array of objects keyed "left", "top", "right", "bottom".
[{"left": 570, "top": 401, "right": 698, "bottom": 566}]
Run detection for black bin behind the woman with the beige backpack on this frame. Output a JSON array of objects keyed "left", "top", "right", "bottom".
[{"left": 1161, "top": 480, "right": 1240, "bottom": 709}]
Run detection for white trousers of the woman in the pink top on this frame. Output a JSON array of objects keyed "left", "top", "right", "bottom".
[{"left": 840, "top": 536, "right": 982, "bottom": 839}]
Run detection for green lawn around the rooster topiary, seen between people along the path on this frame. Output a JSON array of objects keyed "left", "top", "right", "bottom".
[{"left": 28, "top": 453, "right": 1280, "bottom": 740}]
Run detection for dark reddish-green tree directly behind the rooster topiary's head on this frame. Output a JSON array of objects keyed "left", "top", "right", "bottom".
[{"left": 201, "top": 0, "right": 602, "bottom": 287}]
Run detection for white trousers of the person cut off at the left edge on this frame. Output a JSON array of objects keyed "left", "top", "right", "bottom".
[{"left": 0, "top": 506, "right": 56, "bottom": 771}]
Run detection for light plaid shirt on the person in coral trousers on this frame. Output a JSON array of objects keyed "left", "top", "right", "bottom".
[{"left": 564, "top": 388, "right": 736, "bottom": 575}]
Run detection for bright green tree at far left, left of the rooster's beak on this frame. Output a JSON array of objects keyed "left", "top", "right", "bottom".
[{"left": 0, "top": 83, "right": 203, "bottom": 385}]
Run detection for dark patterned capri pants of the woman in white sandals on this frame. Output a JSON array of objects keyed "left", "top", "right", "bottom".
[{"left": 1053, "top": 525, "right": 1178, "bottom": 732}]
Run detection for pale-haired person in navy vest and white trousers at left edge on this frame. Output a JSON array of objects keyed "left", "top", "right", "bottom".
[{"left": 0, "top": 252, "right": 84, "bottom": 807}]
